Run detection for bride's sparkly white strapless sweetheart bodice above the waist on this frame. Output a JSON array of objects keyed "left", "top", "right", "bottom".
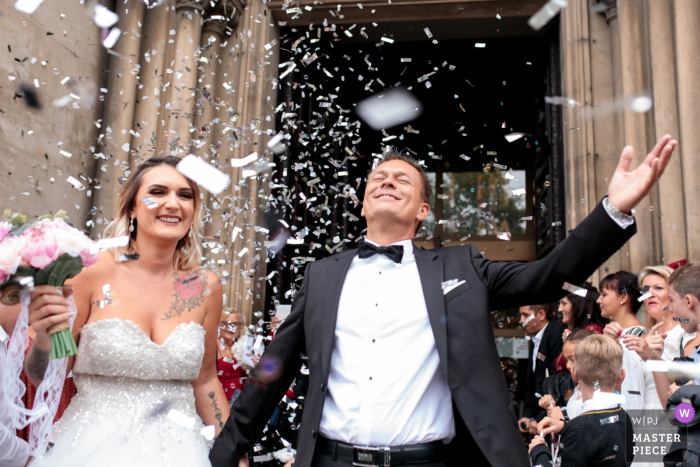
[{"left": 73, "top": 318, "right": 204, "bottom": 381}]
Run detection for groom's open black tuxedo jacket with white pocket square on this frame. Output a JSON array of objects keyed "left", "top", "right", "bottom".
[{"left": 210, "top": 205, "right": 636, "bottom": 467}]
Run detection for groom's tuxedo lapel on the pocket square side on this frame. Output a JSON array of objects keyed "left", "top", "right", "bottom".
[{"left": 413, "top": 246, "right": 447, "bottom": 378}]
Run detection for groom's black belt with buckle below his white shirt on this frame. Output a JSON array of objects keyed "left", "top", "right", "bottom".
[{"left": 316, "top": 436, "right": 445, "bottom": 467}]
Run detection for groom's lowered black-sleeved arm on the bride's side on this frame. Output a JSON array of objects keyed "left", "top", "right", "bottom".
[{"left": 209, "top": 264, "right": 311, "bottom": 467}]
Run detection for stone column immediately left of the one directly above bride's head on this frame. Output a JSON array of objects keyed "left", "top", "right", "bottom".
[{"left": 131, "top": 1, "right": 173, "bottom": 165}]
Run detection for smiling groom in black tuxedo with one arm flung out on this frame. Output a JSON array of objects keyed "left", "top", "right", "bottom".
[{"left": 210, "top": 136, "right": 677, "bottom": 467}]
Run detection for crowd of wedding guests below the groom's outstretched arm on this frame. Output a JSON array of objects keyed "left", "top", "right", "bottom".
[{"left": 518, "top": 264, "right": 700, "bottom": 466}]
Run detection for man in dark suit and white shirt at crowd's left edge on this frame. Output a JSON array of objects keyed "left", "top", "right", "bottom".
[{"left": 518, "top": 303, "right": 564, "bottom": 435}]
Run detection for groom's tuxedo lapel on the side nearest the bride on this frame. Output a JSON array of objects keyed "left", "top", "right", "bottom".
[{"left": 321, "top": 250, "right": 355, "bottom": 377}]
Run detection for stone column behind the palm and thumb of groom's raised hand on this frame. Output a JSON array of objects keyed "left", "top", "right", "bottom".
[{"left": 615, "top": 0, "right": 661, "bottom": 273}]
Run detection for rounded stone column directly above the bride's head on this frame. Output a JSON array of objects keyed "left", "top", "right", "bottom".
[{"left": 158, "top": 0, "right": 204, "bottom": 155}]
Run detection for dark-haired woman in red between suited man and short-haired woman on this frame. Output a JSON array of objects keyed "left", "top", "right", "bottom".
[{"left": 554, "top": 282, "right": 605, "bottom": 374}]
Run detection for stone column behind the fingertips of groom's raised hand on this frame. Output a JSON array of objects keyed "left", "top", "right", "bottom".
[{"left": 647, "top": 0, "right": 687, "bottom": 264}]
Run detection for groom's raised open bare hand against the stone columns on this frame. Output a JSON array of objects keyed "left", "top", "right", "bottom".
[{"left": 608, "top": 135, "right": 678, "bottom": 214}]
